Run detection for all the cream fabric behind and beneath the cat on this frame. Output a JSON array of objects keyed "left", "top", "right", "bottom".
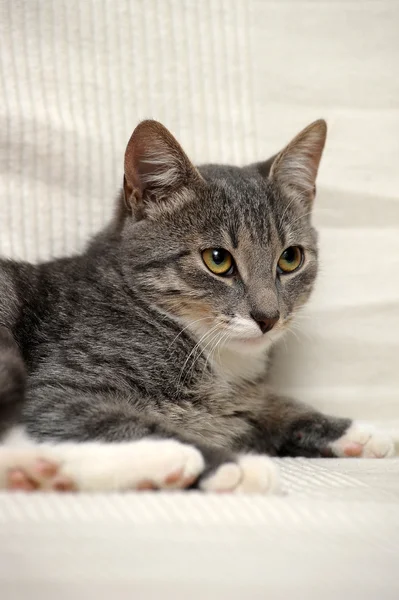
[{"left": 0, "top": 0, "right": 399, "bottom": 600}]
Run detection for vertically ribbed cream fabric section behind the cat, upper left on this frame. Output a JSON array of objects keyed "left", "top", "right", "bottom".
[{"left": 0, "top": 0, "right": 256, "bottom": 258}]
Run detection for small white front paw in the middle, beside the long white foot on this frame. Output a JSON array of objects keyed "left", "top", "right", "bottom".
[{"left": 200, "top": 454, "right": 280, "bottom": 494}]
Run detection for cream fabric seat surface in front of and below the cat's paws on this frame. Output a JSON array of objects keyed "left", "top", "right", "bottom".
[{"left": 0, "top": 459, "right": 399, "bottom": 600}]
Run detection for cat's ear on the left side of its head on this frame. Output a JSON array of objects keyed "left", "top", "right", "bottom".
[{"left": 123, "top": 120, "right": 202, "bottom": 218}]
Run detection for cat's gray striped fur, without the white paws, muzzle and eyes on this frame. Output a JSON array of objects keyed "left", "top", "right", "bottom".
[{"left": 0, "top": 122, "right": 350, "bottom": 480}]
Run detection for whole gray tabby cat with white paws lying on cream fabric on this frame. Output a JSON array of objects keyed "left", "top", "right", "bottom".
[{"left": 0, "top": 121, "right": 393, "bottom": 493}]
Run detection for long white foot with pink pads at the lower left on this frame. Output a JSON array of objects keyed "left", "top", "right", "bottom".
[{"left": 0, "top": 439, "right": 204, "bottom": 492}]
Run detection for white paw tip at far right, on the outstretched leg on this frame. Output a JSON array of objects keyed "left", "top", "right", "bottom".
[{"left": 330, "top": 422, "right": 394, "bottom": 458}]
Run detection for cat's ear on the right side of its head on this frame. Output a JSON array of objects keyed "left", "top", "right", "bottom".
[{"left": 257, "top": 119, "right": 327, "bottom": 203}]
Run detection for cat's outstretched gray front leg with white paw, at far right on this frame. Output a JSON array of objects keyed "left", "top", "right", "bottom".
[{"left": 254, "top": 395, "right": 394, "bottom": 458}]
